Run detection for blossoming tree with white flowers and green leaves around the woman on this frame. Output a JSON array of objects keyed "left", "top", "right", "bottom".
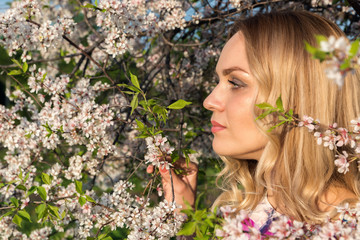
[{"left": 0, "top": 0, "right": 360, "bottom": 239}]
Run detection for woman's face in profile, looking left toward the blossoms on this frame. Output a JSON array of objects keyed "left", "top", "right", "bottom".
[{"left": 204, "top": 32, "right": 268, "bottom": 160}]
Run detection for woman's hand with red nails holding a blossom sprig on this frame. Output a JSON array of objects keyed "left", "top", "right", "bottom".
[{"left": 146, "top": 158, "right": 198, "bottom": 209}]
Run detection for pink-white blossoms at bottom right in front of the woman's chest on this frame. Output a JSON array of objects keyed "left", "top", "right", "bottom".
[{"left": 216, "top": 203, "right": 360, "bottom": 240}]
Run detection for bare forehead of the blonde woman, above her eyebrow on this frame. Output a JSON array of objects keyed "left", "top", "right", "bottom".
[{"left": 216, "top": 32, "right": 250, "bottom": 74}]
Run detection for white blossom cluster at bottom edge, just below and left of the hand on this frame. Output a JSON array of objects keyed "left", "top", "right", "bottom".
[{"left": 57, "top": 181, "right": 184, "bottom": 240}]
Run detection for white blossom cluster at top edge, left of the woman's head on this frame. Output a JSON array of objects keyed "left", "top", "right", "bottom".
[{"left": 96, "top": 0, "right": 186, "bottom": 57}]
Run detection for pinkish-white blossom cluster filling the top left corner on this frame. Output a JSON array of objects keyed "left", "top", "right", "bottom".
[{"left": 0, "top": 0, "right": 75, "bottom": 57}]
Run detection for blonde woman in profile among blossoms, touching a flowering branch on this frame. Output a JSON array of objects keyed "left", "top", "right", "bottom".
[{"left": 150, "top": 12, "right": 360, "bottom": 231}]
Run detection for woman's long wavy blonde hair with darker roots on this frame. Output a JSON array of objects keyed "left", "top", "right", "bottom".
[{"left": 214, "top": 11, "right": 360, "bottom": 222}]
